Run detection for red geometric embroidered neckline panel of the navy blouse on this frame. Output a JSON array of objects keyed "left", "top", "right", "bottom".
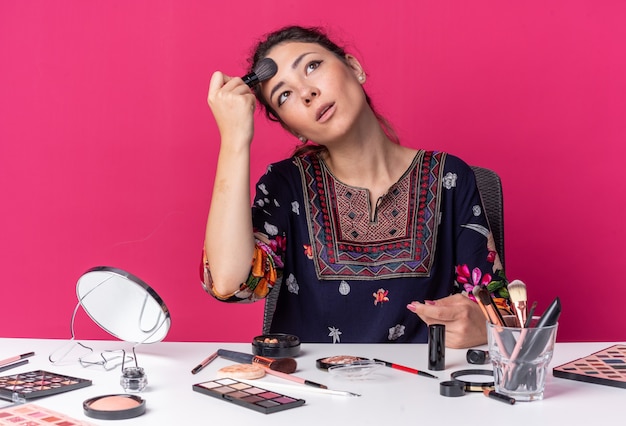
[{"left": 296, "top": 151, "right": 445, "bottom": 280}]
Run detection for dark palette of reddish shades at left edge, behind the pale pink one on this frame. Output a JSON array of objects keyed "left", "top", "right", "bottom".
[{"left": 0, "top": 370, "right": 91, "bottom": 401}]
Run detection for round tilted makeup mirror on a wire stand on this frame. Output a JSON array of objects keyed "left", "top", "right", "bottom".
[{"left": 76, "top": 266, "right": 171, "bottom": 343}]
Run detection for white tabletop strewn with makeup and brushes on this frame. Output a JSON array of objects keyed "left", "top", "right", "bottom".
[{"left": 0, "top": 338, "right": 626, "bottom": 426}]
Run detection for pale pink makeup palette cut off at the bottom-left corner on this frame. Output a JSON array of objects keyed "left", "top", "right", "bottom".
[{"left": 0, "top": 404, "right": 93, "bottom": 426}]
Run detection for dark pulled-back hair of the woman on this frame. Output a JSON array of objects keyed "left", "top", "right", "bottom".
[{"left": 248, "top": 25, "right": 399, "bottom": 155}]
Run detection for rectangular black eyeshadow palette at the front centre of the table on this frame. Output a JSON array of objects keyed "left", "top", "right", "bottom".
[{"left": 193, "top": 378, "right": 305, "bottom": 414}]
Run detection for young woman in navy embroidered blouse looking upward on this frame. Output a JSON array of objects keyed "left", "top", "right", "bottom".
[{"left": 202, "top": 27, "right": 501, "bottom": 348}]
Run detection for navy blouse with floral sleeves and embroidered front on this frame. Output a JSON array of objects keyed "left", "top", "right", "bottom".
[{"left": 202, "top": 151, "right": 501, "bottom": 343}]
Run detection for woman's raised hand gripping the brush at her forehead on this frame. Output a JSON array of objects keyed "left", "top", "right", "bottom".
[{"left": 207, "top": 71, "right": 256, "bottom": 146}]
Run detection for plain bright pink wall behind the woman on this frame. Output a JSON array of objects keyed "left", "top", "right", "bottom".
[{"left": 0, "top": 0, "right": 626, "bottom": 341}]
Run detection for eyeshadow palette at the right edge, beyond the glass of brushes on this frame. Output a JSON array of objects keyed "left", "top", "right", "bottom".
[{"left": 552, "top": 345, "right": 626, "bottom": 388}]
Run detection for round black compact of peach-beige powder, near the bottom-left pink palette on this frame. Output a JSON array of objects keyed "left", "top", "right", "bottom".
[{"left": 83, "top": 394, "right": 146, "bottom": 420}]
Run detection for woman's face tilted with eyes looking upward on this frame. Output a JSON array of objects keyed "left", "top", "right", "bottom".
[{"left": 261, "top": 42, "right": 367, "bottom": 144}]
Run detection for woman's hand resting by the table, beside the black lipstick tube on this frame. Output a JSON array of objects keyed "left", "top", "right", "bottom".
[{"left": 407, "top": 294, "right": 487, "bottom": 349}]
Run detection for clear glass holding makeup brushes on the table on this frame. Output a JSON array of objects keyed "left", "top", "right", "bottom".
[{"left": 479, "top": 280, "right": 561, "bottom": 401}]
